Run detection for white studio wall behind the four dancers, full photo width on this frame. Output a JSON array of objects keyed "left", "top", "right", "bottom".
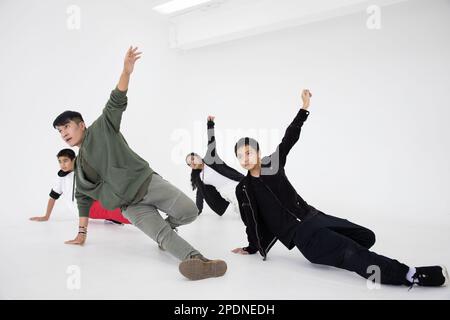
[{"left": 0, "top": 0, "right": 450, "bottom": 227}]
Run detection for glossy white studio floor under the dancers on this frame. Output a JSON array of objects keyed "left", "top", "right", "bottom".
[{"left": 0, "top": 205, "right": 450, "bottom": 300}]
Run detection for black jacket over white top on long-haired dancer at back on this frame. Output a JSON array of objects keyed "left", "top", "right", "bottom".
[{"left": 194, "top": 121, "right": 244, "bottom": 216}]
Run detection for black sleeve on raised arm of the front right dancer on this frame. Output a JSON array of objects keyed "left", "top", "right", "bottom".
[{"left": 271, "top": 109, "right": 309, "bottom": 168}]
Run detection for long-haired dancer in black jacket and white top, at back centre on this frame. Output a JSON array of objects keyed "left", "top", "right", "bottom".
[{"left": 185, "top": 116, "right": 244, "bottom": 216}]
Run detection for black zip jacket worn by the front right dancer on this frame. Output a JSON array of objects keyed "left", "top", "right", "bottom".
[{"left": 236, "top": 109, "right": 311, "bottom": 260}]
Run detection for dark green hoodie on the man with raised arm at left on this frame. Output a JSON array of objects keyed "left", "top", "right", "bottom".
[{"left": 75, "top": 88, "right": 154, "bottom": 217}]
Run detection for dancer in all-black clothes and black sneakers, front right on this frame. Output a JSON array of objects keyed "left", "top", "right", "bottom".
[{"left": 233, "top": 90, "right": 448, "bottom": 287}]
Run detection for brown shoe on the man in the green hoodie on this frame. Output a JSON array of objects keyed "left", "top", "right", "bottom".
[{"left": 179, "top": 254, "right": 227, "bottom": 280}]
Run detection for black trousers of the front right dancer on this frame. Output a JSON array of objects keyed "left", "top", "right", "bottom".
[{"left": 294, "top": 210, "right": 409, "bottom": 285}]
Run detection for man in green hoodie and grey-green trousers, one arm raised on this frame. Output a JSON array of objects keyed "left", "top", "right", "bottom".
[{"left": 53, "top": 47, "right": 227, "bottom": 280}]
